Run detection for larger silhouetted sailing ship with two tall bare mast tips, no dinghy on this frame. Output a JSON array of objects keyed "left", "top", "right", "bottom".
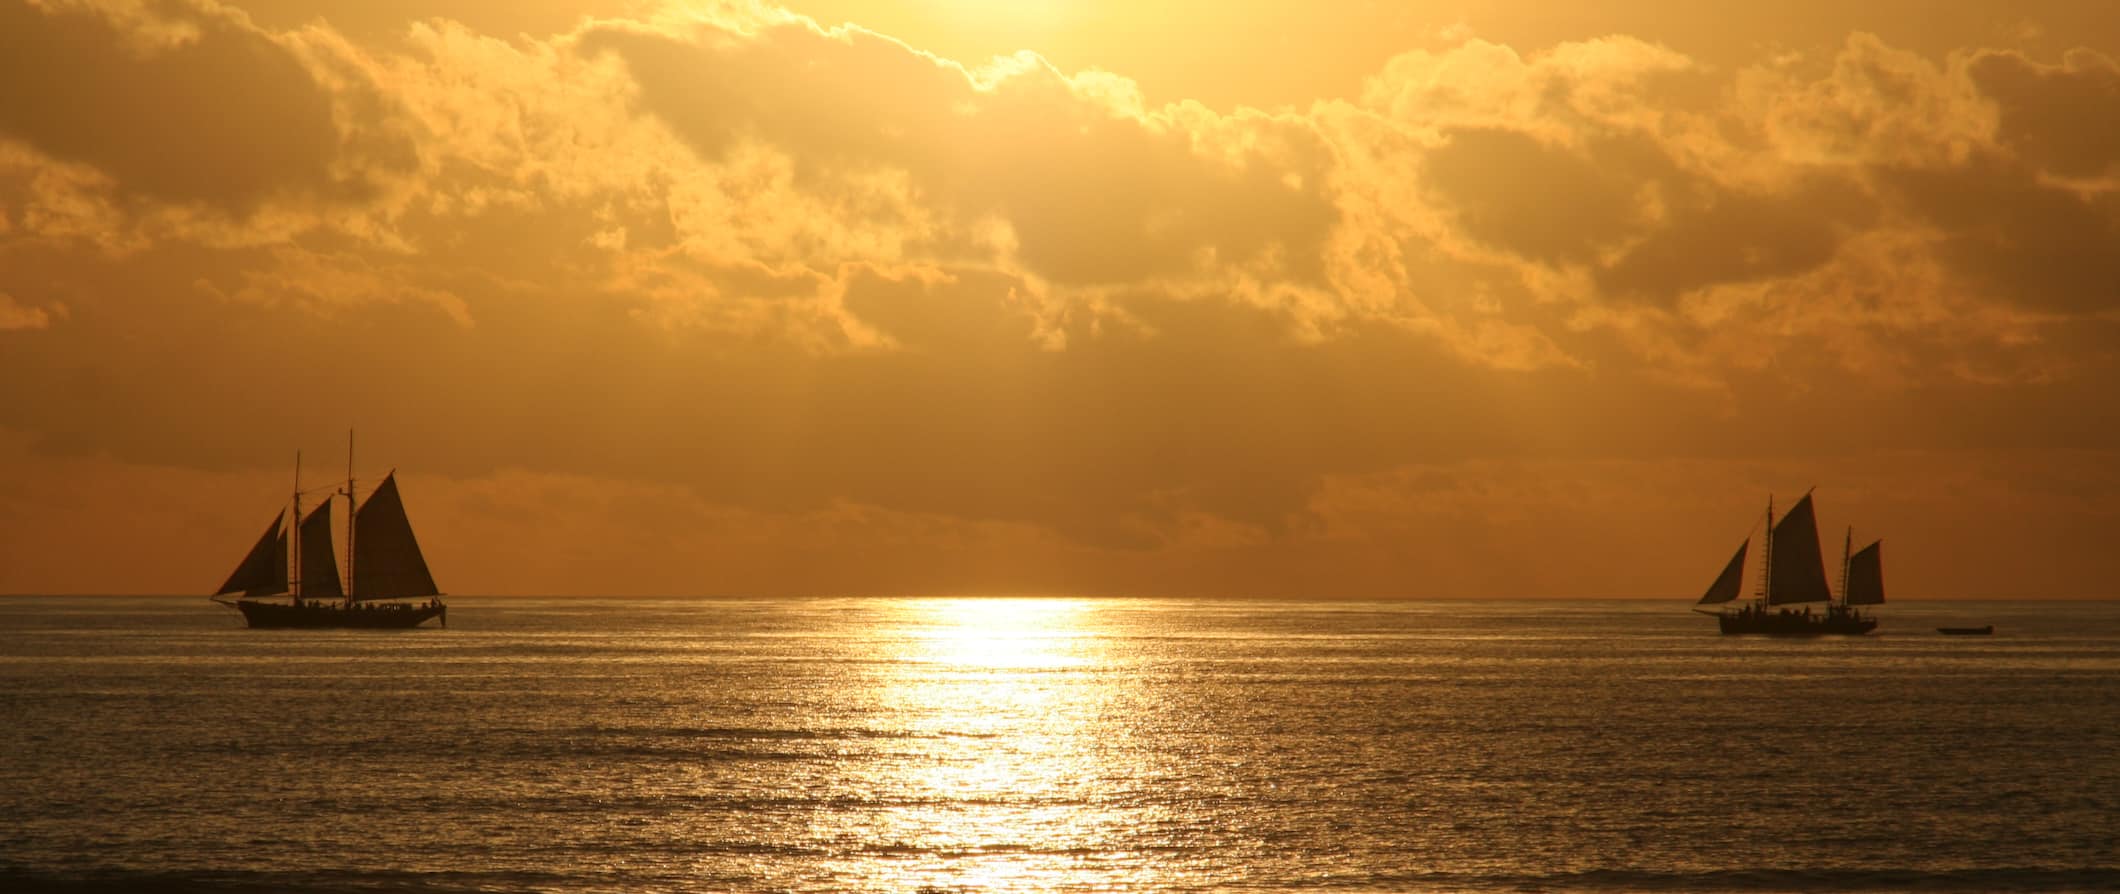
[{"left": 212, "top": 432, "right": 449, "bottom": 627}]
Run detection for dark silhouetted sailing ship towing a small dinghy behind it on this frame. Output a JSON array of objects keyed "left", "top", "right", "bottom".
[{"left": 1694, "top": 491, "right": 1885, "bottom": 636}]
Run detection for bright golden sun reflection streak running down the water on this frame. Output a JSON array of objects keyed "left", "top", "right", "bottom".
[{"left": 840, "top": 600, "right": 1141, "bottom": 890}]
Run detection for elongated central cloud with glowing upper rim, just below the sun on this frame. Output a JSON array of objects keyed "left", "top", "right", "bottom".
[{"left": 583, "top": 21, "right": 1336, "bottom": 284}]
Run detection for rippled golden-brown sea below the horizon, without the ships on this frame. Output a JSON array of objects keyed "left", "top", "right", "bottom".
[{"left": 0, "top": 597, "right": 2120, "bottom": 892}]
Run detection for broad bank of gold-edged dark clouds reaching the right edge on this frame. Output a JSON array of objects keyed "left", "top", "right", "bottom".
[{"left": 1344, "top": 25, "right": 2116, "bottom": 386}]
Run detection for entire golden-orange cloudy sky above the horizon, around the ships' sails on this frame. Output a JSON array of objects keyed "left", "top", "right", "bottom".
[{"left": 0, "top": 0, "right": 2120, "bottom": 600}]
